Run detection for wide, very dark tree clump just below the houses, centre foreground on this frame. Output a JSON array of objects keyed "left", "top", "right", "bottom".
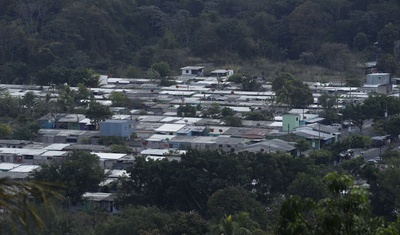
[{"left": 117, "top": 150, "right": 309, "bottom": 215}]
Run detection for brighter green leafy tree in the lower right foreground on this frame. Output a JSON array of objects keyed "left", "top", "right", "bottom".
[{"left": 278, "top": 172, "right": 385, "bottom": 235}]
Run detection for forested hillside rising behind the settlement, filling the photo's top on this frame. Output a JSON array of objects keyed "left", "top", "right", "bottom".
[{"left": 0, "top": 0, "right": 400, "bottom": 85}]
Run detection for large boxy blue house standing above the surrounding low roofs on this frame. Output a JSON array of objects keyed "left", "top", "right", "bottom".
[{"left": 99, "top": 119, "right": 135, "bottom": 137}]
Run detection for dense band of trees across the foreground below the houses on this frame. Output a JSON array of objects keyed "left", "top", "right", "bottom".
[{"left": 0, "top": 149, "right": 400, "bottom": 235}]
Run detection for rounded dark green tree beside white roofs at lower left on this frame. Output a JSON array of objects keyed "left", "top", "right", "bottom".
[{"left": 32, "top": 150, "right": 105, "bottom": 204}]
